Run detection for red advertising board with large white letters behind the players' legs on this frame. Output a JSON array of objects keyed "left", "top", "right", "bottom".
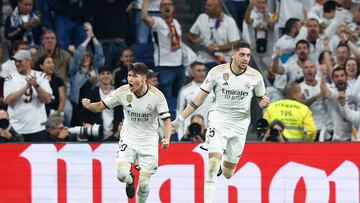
[{"left": 0, "top": 143, "right": 360, "bottom": 203}]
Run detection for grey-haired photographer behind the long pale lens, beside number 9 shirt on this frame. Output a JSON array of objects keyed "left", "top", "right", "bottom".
[{"left": 45, "top": 114, "right": 77, "bottom": 142}]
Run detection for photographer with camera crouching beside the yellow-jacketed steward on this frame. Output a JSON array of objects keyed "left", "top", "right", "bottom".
[{"left": 262, "top": 120, "right": 287, "bottom": 142}]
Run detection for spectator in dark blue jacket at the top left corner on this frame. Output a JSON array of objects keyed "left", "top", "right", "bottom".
[{"left": 5, "top": 0, "right": 42, "bottom": 47}]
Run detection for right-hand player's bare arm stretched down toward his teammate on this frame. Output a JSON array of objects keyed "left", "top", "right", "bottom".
[{"left": 171, "top": 90, "right": 209, "bottom": 133}]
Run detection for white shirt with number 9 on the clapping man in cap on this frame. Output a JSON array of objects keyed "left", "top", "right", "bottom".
[{"left": 4, "top": 70, "right": 52, "bottom": 134}]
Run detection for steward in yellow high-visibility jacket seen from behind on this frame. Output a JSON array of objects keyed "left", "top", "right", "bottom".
[{"left": 263, "top": 82, "right": 316, "bottom": 142}]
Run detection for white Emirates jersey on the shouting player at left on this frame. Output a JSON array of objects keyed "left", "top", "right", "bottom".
[{"left": 102, "top": 85, "right": 170, "bottom": 146}]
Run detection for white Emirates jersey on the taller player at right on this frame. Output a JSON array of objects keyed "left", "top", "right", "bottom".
[{"left": 200, "top": 63, "right": 266, "bottom": 127}]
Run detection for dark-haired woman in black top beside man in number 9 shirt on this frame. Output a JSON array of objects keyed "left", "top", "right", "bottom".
[{"left": 37, "top": 55, "right": 67, "bottom": 116}]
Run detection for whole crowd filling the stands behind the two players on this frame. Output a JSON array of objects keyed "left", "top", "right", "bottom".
[{"left": 0, "top": 0, "right": 360, "bottom": 142}]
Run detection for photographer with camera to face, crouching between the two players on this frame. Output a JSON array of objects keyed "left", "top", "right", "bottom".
[{"left": 181, "top": 114, "right": 205, "bottom": 143}]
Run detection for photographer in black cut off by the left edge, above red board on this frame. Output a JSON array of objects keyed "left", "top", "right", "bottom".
[{"left": 0, "top": 110, "right": 24, "bottom": 142}]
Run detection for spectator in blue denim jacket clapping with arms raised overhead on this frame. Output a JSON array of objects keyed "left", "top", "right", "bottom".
[{"left": 69, "top": 23, "right": 105, "bottom": 126}]
